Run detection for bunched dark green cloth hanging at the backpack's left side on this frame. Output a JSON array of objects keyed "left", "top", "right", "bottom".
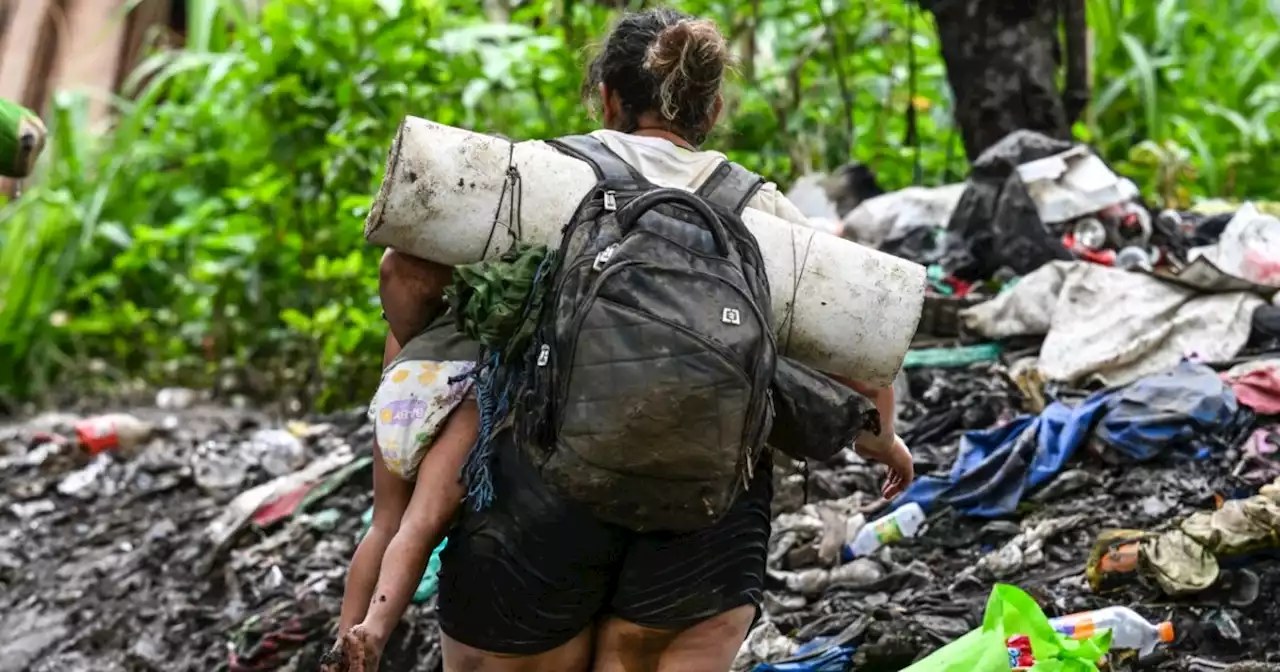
[{"left": 444, "top": 243, "right": 552, "bottom": 361}]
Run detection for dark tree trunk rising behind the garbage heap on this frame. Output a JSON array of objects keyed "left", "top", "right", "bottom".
[{"left": 919, "top": 0, "right": 1087, "bottom": 161}]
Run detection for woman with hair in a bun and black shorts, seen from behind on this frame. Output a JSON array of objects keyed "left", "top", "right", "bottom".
[{"left": 334, "top": 9, "right": 914, "bottom": 672}]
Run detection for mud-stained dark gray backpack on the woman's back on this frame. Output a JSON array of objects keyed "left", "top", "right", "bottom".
[{"left": 513, "top": 136, "right": 776, "bottom": 531}]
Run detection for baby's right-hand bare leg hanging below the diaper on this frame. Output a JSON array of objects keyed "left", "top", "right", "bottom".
[{"left": 361, "top": 402, "right": 480, "bottom": 653}]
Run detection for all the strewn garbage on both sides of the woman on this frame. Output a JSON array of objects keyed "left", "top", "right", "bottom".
[{"left": 0, "top": 133, "right": 1280, "bottom": 672}]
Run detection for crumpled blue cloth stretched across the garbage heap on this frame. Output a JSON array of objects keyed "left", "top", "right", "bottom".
[{"left": 893, "top": 361, "right": 1252, "bottom": 518}]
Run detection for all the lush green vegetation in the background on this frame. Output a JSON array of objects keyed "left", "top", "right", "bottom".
[{"left": 0, "top": 0, "right": 1280, "bottom": 406}]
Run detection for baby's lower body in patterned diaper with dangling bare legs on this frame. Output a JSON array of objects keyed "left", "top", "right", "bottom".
[{"left": 321, "top": 315, "right": 480, "bottom": 672}]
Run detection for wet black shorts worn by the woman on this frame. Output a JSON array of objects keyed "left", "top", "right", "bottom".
[{"left": 438, "top": 433, "right": 773, "bottom": 655}]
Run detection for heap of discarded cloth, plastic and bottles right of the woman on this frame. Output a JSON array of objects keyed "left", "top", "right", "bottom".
[{"left": 735, "top": 132, "right": 1280, "bottom": 672}]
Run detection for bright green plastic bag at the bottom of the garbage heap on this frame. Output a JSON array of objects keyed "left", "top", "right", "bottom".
[{"left": 905, "top": 584, "right": 1111, "bottom": 672}]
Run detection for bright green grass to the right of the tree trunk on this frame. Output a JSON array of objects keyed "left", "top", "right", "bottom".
[{"left": 1088, "top": 0, "right": 1280, "bottom": 205}]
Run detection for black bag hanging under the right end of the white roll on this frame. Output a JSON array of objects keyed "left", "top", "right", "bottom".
[{"left": 769, "top": 357, "right": 881, "bottom": 462}]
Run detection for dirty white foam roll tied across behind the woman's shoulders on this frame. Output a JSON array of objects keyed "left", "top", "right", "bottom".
[{"left": 365, "top": 116, "right": 925, "bottom": 387}]
